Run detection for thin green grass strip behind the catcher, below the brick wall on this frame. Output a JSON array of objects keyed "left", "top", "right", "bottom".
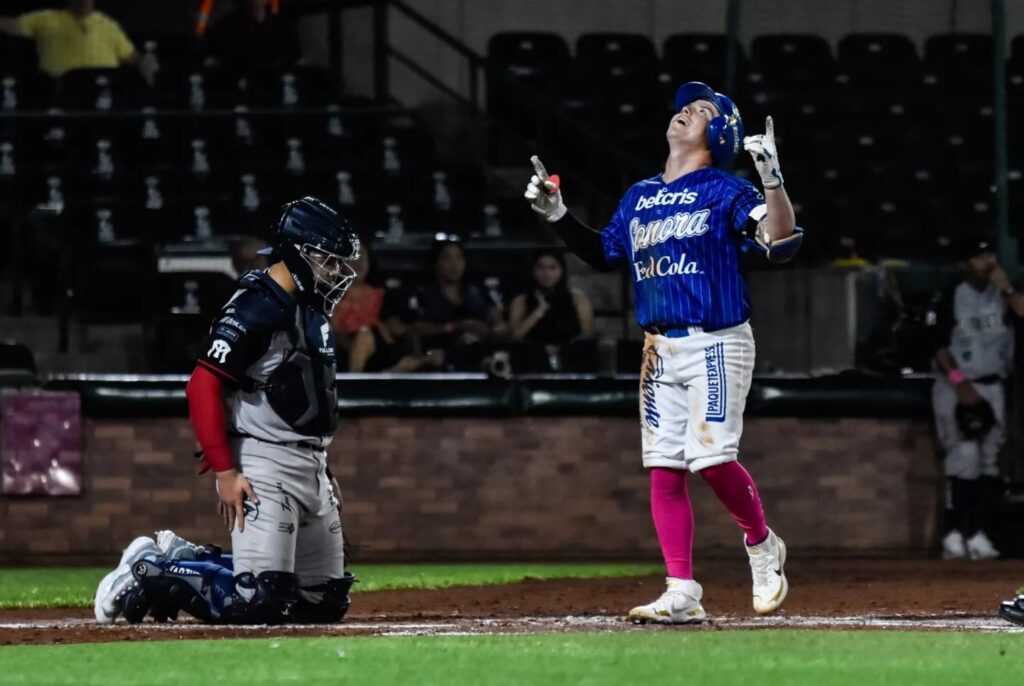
[{"left": 0, "top": 563, "right": 663, "bottom": 608}]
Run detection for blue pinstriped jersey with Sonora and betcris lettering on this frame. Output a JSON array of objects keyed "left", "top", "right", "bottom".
[{"left": 601, "top": 167, "right": 767, "bottom": 331}]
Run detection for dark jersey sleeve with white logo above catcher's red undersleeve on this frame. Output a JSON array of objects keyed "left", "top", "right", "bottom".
[{"left": 197, "top": 291, "right": 288, "bottom": 386}]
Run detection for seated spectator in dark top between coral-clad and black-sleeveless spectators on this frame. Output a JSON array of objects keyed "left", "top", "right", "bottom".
[{"left": 413, "top": 240, "right": 502, "bottom": 371}]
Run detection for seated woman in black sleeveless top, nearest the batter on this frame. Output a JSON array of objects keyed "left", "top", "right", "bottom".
[{"left": 509, "top": 250, "right": 595, "bottom": 372}]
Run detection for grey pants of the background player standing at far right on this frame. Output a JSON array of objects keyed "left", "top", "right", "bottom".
[{"left": 932, "top": 377, "right": 1007, "bottom": 479}]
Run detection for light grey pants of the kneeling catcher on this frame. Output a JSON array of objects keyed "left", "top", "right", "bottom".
[{"left": 224, "top": 438, "right": 345, "bottom": 588}]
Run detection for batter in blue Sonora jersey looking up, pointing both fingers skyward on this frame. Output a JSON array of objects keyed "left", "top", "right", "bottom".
[{"left": 525, "top": 82, "right": 803, "bottom": 624}]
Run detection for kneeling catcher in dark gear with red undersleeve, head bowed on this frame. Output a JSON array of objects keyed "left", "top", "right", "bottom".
[{"left": 95, "top": 198, "right": 359, "bottom": 624}]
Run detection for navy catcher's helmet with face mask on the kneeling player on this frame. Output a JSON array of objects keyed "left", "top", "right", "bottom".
[{"left": 261, "top": 197, "right": 359, "bottom": 316}]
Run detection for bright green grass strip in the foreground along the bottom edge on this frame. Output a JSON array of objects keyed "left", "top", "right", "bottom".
[{"left": 0, "top": 631, "right": 1024, "bottom": 686}]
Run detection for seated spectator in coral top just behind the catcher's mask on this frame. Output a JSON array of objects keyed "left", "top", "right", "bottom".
[{"left": 331, "top": 243, "right": 440, "bottom": 373}]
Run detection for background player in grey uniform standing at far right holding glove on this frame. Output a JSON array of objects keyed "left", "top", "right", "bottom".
[{"left": 932, "top": 237, "right": 1024, "bottom": 560}]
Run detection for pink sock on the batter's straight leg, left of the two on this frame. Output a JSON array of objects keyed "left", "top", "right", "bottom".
[{"left": 650, "top": 467, "right": 693, "bottom": 578}]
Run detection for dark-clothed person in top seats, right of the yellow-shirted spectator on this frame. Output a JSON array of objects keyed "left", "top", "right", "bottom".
[{"left": 207, "top": 0, "right": 299, "bottom": 72}]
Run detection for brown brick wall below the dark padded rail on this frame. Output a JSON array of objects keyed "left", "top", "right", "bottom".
[{"left": 0, "top": 418, "right": 940, "bottom": 563}]
